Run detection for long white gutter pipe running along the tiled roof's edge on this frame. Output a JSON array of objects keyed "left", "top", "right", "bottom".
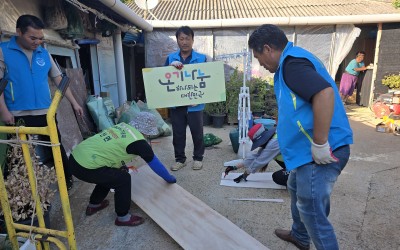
[{"left": 148, "top": 14, "right": 400, "bottom": 29}]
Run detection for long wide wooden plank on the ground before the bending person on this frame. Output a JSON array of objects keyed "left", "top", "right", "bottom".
[{"left": 131, "top": 165, "right": 268, "bottom": 250}]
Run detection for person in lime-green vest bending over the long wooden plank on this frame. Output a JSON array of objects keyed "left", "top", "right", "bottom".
[{"left": 69, "top": 113, "right": 176, "bottom": 226}]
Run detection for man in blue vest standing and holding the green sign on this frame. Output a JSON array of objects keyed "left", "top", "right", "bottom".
[{"left": 165, "top": 26, "right": 207, "bottom": 171}]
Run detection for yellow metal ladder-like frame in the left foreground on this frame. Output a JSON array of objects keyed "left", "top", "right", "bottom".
[{"left": 0, "top": 76, "right": 77, "bottom": 250}]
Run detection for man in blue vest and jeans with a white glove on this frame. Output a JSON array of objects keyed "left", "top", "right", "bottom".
[{"left": 248, "top": 24, "right": 353, "bottom": 249}]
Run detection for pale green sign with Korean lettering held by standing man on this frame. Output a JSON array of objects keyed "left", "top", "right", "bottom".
[{"left": 142, "top": 61, "right": 226, "bottom": 108}]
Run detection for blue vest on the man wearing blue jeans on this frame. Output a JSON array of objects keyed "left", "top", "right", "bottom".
[{"left": 274, "top": 42, "right": 353, "bottom": 171}]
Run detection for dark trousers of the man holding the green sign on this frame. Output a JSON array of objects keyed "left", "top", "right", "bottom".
[{"left": 170, "top": 106, "right": 204, "bottom": 163}]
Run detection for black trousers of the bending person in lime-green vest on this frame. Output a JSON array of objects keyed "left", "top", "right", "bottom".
[{"left": 69, "top": 155, "right": 131, "bottom": 216}]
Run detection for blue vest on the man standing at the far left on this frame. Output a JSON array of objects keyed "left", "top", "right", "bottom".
[{"left": 0, "top": 37, "right": 51, "bottom": 111}]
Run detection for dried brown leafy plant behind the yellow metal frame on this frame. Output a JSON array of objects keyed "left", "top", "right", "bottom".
[{"left": 0, "top": 136, "right": 57, "bottom": 229}]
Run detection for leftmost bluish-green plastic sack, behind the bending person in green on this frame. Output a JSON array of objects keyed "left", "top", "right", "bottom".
[{"left": 86, "top": 95, "right": 115, "bottom": 131}]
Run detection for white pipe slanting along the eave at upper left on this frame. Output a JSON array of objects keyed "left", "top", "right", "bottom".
[{"left": 99, "top": 0, "right": 153, "bottom": 32}]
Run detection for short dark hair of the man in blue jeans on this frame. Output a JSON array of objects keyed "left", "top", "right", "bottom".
[{"left": 248, "top": 24, "right": 288, "bottom": 53}]
